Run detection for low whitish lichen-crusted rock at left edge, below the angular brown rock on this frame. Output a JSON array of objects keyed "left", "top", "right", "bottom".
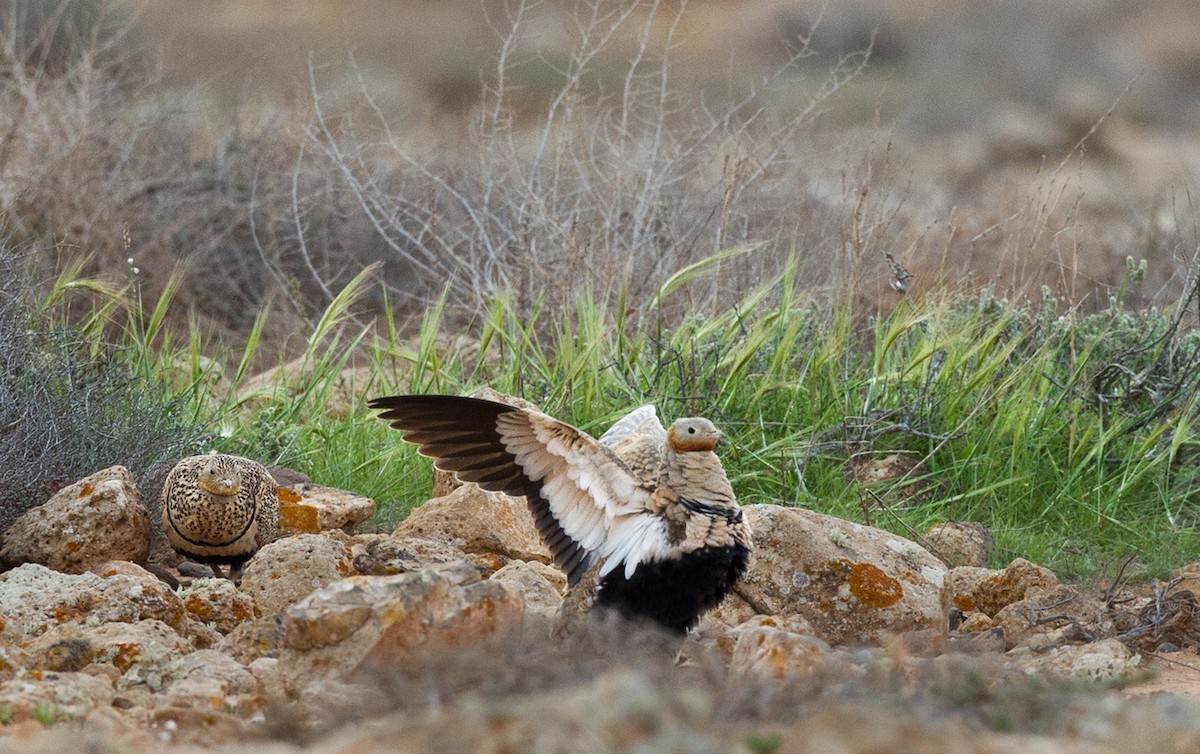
[{"left": 0, "top": 563, "right": 188, "bottom": 642}]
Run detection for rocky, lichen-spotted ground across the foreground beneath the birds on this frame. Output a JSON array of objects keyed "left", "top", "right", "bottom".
[{"left": 0, "top": 451, "right": 1200, "bottom": 752}]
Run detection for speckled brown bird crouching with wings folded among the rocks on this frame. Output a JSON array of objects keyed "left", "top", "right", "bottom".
[{"left": 162, "top": 453, "right": 280, "bottom": 579}]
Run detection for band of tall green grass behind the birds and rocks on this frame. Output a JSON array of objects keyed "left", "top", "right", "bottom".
[{"left": 21, "top": 255, "right": 1200, "bottom": 579}]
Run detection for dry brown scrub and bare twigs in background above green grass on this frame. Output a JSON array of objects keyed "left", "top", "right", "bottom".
[{"left": 7, "top": 0, "right": 1200, "bottom": 362}]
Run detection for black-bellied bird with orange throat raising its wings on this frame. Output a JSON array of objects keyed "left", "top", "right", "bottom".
[{"left": 370, "top": 395, "right": 751, "bottom": 632}]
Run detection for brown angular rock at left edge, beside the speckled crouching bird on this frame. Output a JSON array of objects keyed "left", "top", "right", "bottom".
[{"left": 0, "top": 466, "right": 150, "bottom": 574}]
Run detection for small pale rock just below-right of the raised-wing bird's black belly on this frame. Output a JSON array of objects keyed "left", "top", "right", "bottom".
[{"left": 728, "top": 616, "right": 832, "bottom": 681}]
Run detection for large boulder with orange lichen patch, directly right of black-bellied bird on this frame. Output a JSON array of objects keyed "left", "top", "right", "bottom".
[{"left": 734, "top": 505, "right": 947, "bottom": 645}]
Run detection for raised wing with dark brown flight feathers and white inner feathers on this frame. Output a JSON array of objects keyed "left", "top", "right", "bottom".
[{"left": 368, "top": 395, "right": 670, "bottom": 585}]
